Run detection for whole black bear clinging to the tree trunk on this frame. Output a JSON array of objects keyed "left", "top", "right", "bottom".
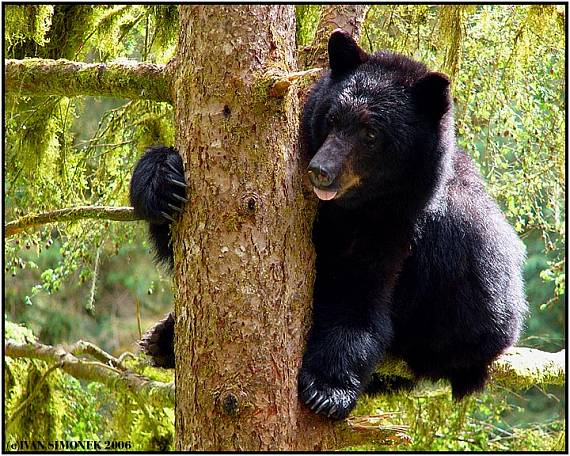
[{"left": 131, "top": 30, "right": 526, "bottom": 419}]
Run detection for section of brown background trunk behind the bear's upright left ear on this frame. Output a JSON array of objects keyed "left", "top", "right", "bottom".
[{"left": 298, "top": 4, "right": 369, "bottom": 68}]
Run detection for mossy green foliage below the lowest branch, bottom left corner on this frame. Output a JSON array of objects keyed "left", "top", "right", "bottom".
[{"left": 4, "top": 321, "right": 174, "bottom": 451}]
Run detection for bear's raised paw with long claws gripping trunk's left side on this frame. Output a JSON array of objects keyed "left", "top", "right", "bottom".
[{"left": 131, "top": 147, "right": 188, "bottom": 224}]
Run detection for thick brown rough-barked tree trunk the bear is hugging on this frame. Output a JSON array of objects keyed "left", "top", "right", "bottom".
[{"left": 170, "top": 5, "right": 320, "bottom": 451}]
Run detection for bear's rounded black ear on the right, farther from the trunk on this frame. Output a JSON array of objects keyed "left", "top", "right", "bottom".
[{"left": 412, "top": 72, "right": 451, "bottom": 120}]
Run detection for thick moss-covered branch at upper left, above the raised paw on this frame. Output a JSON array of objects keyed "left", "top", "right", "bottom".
[{"left": 4, "top": 59, "right": 172, "bottom": 102}]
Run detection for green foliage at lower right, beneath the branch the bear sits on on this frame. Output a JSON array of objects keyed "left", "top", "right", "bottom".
[{"left": 350, "top": 384, "right": 565, "bottom": 452}]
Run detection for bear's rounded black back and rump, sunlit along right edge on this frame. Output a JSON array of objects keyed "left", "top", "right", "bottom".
[{"left": 392, "top": 150, "right": 527, "bottom": 368}]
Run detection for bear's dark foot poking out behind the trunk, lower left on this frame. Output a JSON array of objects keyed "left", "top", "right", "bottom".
[{"left": 139, "top": 312, "right": 174, "bottom": 369}]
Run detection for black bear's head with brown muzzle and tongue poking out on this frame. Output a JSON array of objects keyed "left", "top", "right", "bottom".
[{"left": 304, "top": 29, "right": 454, "bottom": 206}]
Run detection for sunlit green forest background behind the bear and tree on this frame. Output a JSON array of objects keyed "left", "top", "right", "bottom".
[{"left": 4, "top": 5, "right": 566, "bottom": 451}]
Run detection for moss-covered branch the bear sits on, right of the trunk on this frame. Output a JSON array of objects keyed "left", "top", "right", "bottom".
[{"left": 377, "top": 347, "right": 566, "bottom": 389}]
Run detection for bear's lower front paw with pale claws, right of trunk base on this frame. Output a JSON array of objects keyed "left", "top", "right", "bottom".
[{"left": 299, "top": 368, "right": 358, "bottom": 420}]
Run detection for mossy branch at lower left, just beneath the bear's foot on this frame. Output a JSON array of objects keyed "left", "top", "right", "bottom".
[{"left": 4, "top": 340, "right": 174, "bottom": 407}]
